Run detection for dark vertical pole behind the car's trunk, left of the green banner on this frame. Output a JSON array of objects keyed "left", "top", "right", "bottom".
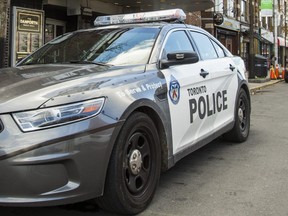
[{"left": 249, "top": 0, "right": 255, "bottom": 79}]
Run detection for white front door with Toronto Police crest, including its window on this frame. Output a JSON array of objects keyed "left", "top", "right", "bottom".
[{"left": 161, "top": 30, "right": 213, "bottom": 154}]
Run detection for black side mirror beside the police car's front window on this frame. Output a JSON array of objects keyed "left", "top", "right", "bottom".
[{"left": 160, "top": 52, "right": 199, "bottom": 69}]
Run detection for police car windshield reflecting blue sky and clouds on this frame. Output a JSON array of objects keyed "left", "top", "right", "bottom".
[{"left": 19, "top": 27, "right": 159, "bottom": 66}]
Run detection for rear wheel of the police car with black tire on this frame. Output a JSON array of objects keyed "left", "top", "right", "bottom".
[{"left": 224, "top": 89, "right": 251, "bottom": 142}]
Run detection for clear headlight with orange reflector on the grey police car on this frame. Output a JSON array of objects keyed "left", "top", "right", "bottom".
[{"left": 12, "top": 98, "right": 105, "bottom": 132}]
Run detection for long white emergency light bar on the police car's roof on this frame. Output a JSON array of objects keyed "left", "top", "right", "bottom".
[{"left": 94, "top": 9, "right": 186, "bottom": 26}]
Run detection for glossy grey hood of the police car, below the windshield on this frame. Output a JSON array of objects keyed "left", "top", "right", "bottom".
[{"left": 0, "top": 64, "right": 145, "bottom": 113}]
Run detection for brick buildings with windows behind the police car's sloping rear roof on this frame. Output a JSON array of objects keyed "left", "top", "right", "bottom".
[{"left": 202, "top": 0, "right": 273, "bottom": 77}]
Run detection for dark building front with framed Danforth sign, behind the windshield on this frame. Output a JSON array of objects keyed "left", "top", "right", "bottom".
[{"left": 0, "top": 0, "right": 214, "bottom": 67}]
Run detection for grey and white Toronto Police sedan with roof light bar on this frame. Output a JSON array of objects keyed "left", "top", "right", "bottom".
[{"left": 0, "top": 9, "right": 250, "bottom": 214}]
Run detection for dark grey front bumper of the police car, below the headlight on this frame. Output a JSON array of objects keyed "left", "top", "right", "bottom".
[{"left": 0, "top": 114, "right": 119, "bottom": 206}]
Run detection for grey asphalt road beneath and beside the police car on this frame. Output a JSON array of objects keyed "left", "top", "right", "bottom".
[{"left": 0, "top": 82, "right": 288, "bottom": 216}]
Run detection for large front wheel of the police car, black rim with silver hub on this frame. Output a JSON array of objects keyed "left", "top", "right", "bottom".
[{"left": 96, "top": 112, "right": 161, "bottom": 215}]
